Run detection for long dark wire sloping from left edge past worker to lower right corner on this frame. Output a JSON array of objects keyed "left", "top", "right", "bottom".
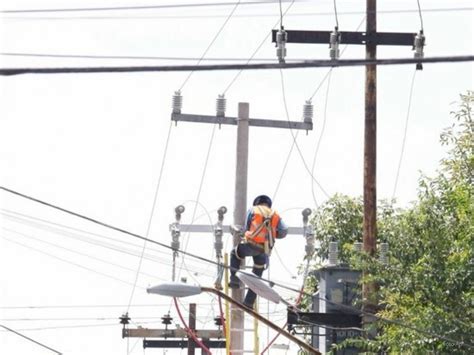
[{"left": 0, "top": 186, "right": 474, "bottom": 348}]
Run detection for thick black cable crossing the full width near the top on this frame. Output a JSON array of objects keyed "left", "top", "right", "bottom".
[{"left": 0, "top": 55, "right": 474, "bottom": 76}]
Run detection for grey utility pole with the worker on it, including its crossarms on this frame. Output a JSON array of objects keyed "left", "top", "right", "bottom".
[{"left": 171, "top": 96, "right": 313, "bottom": 354}]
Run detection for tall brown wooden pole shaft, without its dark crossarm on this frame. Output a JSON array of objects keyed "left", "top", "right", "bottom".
[{"left": 362, "top": 0, "right": 377, "bottom": 324}]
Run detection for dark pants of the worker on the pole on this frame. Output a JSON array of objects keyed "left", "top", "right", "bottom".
[{"left": 230, "top": 243, "right": 266, "bottom": 307}]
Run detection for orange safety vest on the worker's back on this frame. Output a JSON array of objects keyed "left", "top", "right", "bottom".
[{"left": 245, "top": 206, "right": 280, "bottom": 249}]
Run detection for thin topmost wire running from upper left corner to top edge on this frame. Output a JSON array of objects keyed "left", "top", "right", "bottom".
[{"left": 0, "top": 0, "right": 290, "bottom": 14}]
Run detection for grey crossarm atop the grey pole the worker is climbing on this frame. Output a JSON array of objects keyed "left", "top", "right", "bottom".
[{"left": 171, "top": 113, "right": 313, "bottom": 131}]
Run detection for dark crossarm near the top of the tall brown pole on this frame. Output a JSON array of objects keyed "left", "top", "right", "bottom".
[{"left": 272, "top": 30, "right": 416, "bottom": 46}]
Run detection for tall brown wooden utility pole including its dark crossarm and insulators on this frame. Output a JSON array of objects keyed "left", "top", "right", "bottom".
[{"left": 272, "top": 0, "right": 425, "bottom": 338}]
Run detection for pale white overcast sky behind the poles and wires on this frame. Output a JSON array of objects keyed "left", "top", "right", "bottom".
[{"left": 0, "top": 0, "right": 474, "bottom": 355}]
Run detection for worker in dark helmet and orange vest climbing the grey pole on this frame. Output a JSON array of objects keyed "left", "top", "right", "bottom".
[{"left": 229, "top": 195, "right": 288, "bottom": 308}]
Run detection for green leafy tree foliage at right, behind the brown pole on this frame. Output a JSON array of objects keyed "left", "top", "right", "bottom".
[{"left": 304, "top": 92, "right": 474, "bottom": 354}]
